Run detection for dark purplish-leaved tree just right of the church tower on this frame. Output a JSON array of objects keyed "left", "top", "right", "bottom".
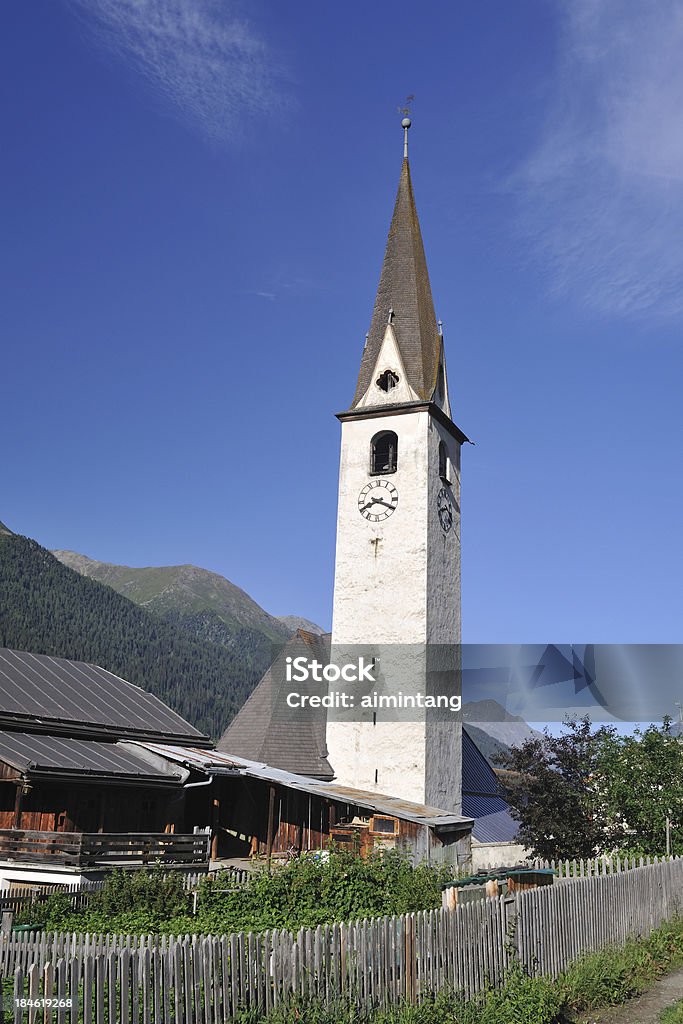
[{"left": 501, "top": 717, "right": 620, "bottom": 859}]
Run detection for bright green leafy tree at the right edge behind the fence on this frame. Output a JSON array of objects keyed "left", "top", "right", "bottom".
[{"left": 596, "top": 719, "right": 683, "bottom": 856}]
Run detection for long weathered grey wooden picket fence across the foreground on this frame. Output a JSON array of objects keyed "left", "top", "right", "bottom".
[{"left": 0, "top": 859, "right": 683, "bottom": 1024}]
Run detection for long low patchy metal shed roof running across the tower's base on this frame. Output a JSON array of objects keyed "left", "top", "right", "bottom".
[{"left": 139, "top": 742, "right": 472, "bottom": 829}]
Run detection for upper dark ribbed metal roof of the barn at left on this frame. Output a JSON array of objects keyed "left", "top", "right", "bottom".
[{"left": 0, "top": 648, "right": 208, "bottom": 744}]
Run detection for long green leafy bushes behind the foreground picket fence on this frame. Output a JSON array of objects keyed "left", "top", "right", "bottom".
[{"left": 20, "top": 849, "right": 453, "bottom": 935}]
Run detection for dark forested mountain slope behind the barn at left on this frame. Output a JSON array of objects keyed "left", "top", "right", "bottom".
[{"left": 0, "top": 528, "right": 270, "bottom": 738}]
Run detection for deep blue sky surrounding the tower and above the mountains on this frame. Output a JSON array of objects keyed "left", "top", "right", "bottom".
[{"left": 0, "top": 0, "right": 683, "bottom": 643}]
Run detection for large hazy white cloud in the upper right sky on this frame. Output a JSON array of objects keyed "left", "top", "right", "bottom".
[{"left": 515, "top": 0, "right": 683, "bottom": 316}]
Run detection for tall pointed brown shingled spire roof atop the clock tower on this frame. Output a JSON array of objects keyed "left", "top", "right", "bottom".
[{"left": 351, "top": 157, "right": 441, "bottom": 408}]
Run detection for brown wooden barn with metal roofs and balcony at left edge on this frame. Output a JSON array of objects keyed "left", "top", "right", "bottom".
[{"left": 0, "top": 648, "right": 210, "bottom": 888}]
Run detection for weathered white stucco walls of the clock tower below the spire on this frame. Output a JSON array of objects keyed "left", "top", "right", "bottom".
[{"left": 328, "top": 395, "right": 461, "bottom": 811}]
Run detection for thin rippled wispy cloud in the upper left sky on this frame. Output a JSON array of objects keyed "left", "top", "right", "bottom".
[{"left": 68, "top": 0, "right": 285, "bottom": 141}]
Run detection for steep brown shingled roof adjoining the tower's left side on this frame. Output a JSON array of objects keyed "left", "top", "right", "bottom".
[{"left": 218, "top": 630, "right": 334, "bottom": 778}]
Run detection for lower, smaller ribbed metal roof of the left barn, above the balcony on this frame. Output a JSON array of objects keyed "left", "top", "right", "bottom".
[{"left": 0, "top": 731, "right": 186, "bottom": 783}]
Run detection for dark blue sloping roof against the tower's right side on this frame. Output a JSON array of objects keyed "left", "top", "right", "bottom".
[{"left": 463, "top": 726, "right": 519, "bottom": 843}]
